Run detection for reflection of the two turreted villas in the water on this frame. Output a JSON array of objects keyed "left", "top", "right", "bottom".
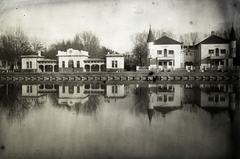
[{"left": 134, "top": 84, "right": 236, "bottom": 124}]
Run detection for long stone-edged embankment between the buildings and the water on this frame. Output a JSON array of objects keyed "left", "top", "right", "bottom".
[{"left": 0, "top": 71, "right": 240, "bottom": 82}]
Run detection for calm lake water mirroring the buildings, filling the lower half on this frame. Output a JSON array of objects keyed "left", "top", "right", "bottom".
[{"left": 0, "top": 83, "right": 240, "bottom": 159}]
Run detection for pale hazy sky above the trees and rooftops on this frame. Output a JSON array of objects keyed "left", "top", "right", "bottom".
[{"left": 0, "top": 0, "right": 240, "bottom": 53}]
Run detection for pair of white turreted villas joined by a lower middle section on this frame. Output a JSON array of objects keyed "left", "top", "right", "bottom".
[{"left": 147, "top": 27, "right": 236, "bottom": 71}]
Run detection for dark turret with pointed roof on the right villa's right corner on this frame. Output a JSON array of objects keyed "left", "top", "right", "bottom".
[{"left": 229, "top": 26, "right": 237, "bottom": 58}]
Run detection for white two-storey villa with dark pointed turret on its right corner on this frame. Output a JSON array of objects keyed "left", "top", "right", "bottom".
[{"left": 196, "top": 27, "right": 236, "bottom": 70}]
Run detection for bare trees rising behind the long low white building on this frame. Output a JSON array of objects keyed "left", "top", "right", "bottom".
[{"left": 0, "top": 27, "right": 116, "bottom": 66}]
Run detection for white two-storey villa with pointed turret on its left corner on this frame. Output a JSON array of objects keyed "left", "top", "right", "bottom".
[{"left": 147, "top": 28, "right": 181, "bottom": 70}]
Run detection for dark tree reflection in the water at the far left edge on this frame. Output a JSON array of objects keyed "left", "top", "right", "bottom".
[{"left": 0, "top": 84, "right": 42, "bottom": 122}]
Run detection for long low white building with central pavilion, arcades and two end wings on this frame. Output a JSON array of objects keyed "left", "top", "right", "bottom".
[{"left": 21, "top": 48, "right": 124, "bottom": 72}]
